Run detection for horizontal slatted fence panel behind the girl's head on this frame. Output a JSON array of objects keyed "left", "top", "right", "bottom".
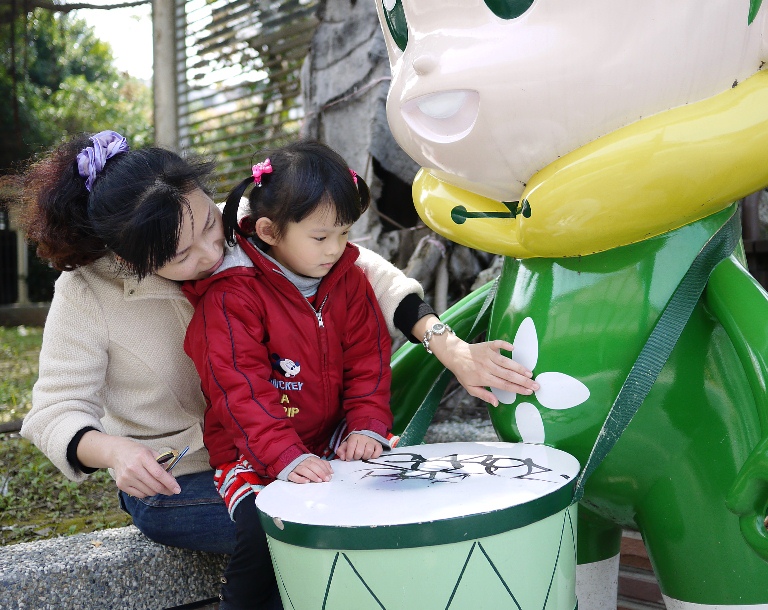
[{"left": 176, "top": 0, "right": 317, "bottom": 193}]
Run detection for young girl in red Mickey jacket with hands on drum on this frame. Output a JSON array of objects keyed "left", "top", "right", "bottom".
[{"left": 184, "top": 142, "right": 392, "bottom": 609}]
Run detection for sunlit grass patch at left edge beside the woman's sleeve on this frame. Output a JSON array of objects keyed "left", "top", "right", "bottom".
[{"left": 0, "top": 326, "right": 43, "bottom": 422}]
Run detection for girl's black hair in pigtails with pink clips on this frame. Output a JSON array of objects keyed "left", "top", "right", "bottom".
[{"left": 224, "top": 140, "right": 371, "bottom": 245}]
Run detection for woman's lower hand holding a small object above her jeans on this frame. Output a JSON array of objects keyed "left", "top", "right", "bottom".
[{"left": 77, "top": 430, "right": 181, "bottom": 498}]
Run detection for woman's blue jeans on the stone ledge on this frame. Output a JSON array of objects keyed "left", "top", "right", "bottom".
[{"left": 119, "top": 470, "right": 237, "bottom": 555}]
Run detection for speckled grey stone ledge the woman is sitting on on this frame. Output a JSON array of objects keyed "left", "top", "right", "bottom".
[{"left": 0, "top": 525, "right": 227, "bottom": 610}]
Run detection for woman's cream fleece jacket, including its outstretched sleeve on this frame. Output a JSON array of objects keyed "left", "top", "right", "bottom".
[{"left": 21, "top": 248, "right": 423, "bottom": 481}]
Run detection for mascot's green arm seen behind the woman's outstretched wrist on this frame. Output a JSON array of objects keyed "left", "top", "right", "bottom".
[{"left": 390, "top": 282, "right": 493, "bottom": 436}]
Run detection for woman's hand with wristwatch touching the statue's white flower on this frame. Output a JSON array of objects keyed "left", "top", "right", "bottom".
[{"left": 413, "top": 315, "right": 539, "bottom": 407}]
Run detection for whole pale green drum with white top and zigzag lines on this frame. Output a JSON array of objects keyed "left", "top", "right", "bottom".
[{"left": 257, "top": 443, "right": 579, "bottom": 610}]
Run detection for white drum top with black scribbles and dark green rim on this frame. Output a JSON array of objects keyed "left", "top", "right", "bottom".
[{"left": 256, "top": 443, "right": 579, "bottom": 549}]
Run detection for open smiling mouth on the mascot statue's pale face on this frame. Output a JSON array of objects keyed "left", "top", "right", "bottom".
[{"left": 402, "top": 89, "right": 480, "bottom": 142}]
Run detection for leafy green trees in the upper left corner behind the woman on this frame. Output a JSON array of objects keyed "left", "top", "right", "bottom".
[{"left": 0, "top": 5, "right": 153, "bottom": 170}]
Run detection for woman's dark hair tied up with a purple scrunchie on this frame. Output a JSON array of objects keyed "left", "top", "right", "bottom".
[{"left": 15, "top": 134, "right": 214, "bottom": 278}]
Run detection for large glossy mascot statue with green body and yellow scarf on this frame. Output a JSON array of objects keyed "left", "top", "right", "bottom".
[{"left": 376, "top": 0, "right": 768, "bottom": 610}]
